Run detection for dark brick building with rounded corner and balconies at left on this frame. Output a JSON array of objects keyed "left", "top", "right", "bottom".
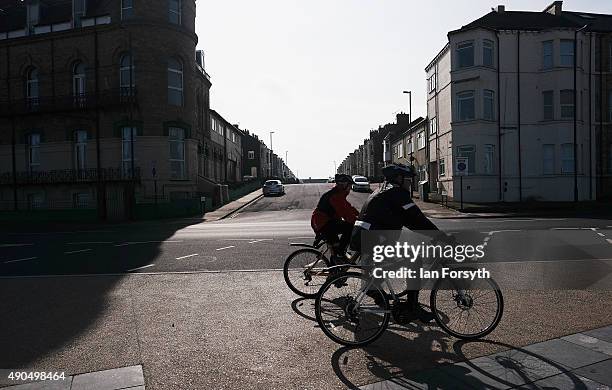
[{"left": 0, "top": 0, "right": 213, "bottom": 218}]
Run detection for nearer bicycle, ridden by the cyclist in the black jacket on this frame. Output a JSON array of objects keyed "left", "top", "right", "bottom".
[{"left": 315, "top": 253, "right": 504, "bottom": 346}]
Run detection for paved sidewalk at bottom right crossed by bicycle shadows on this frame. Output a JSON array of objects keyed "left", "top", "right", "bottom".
[{"left": 361, "top": 325, "right": 612, "bottom": 390}]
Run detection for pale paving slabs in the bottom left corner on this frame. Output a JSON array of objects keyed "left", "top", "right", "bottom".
[{"left": 5, "top": 365, "right": 145, "bottom": 390}]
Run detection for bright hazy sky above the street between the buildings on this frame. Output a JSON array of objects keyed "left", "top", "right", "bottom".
[{"left": 196, "top": 0, "right": 612, "bottom": 178}]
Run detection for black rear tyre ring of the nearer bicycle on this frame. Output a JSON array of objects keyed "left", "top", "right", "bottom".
[{"left": 315, "top": 272, "right": 391, "bottom": 347}]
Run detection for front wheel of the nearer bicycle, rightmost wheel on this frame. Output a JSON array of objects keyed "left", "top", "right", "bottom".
[{"left": 430, "top": 267, "right": 504, "bottom": 340}]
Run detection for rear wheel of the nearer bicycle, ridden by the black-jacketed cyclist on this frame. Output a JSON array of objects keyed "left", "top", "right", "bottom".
[{"left": 315, "top": 272, "right": 390, "bottom": 346}]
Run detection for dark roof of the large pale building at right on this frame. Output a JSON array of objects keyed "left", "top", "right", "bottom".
[{"left": 449, "top": 11, "right": 612, "bottom": 34}]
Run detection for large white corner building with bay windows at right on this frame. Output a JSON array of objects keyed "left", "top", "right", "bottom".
[{"left": 425, "top": 1, "right": 612, "bottom": 202}]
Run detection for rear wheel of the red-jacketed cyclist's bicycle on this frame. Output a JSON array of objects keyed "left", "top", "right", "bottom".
[{"left": 283, "top": 248, "right": 329, "bottom": 298}]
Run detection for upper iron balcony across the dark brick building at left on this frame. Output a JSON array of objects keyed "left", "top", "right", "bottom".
[{"left": 0, "top": 88, "right": 138, "bottom": 117}]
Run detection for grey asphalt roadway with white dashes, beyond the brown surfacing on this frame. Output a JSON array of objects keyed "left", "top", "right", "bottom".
[{"left": 0, "top": 184, "right": 612, "bottom": 276}]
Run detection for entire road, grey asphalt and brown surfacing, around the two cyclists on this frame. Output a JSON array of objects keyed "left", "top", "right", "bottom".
[{"left": 0, "top": 184, "right": 612, "bottom": 390}]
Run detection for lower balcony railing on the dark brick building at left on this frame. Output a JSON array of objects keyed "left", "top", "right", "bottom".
[{"left": 0, "top": 167, "right": 141, "bottom": 186}]
